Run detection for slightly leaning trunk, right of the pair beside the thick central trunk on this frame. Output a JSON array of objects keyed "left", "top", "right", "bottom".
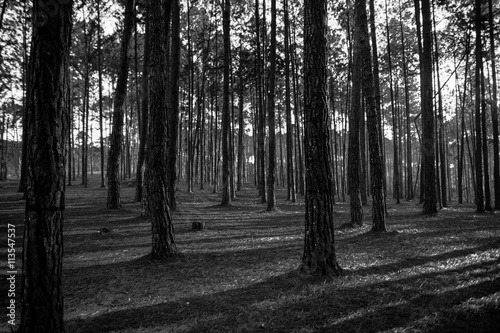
[{"left": 353, "top": 0, "right": 387, "bottom": 232}]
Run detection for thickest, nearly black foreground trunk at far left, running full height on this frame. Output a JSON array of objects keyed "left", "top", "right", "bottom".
[{"left": 19, "top": 1, "right": 72, "bottom": 333}]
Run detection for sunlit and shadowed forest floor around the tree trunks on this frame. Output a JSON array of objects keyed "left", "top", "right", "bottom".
[{"left": 0, "top": 176, "right": 500, "bottom": 333}]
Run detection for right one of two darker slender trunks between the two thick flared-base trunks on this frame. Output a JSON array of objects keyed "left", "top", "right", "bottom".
[{"left": 267, "top": 0, "right": 276, "bottom": 211}]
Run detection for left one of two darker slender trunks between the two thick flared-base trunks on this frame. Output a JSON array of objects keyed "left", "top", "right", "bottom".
[{"left": 221, "top": 0, "right": 231, "bottom": 206}]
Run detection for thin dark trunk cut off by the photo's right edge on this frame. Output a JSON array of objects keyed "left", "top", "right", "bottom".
[{"left": 488, "top": 0, "right": 500, "bottom": 210}]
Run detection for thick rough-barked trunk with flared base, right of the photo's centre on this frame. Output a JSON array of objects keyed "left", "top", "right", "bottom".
[{"left": 301, "top": 0, "right": 342, "bottom": 275}]
